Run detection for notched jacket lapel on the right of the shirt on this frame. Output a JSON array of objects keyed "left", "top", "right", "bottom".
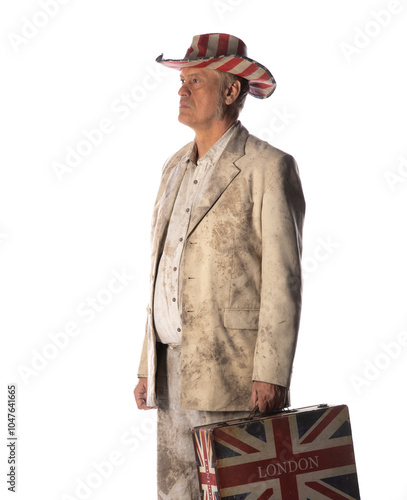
[{"left": 188, "top": 123, "right": 249, "bottom": 236}]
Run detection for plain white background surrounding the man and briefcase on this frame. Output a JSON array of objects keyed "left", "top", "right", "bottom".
[{"left": 0, "top": 0, "right": 407, "bottom": 500}]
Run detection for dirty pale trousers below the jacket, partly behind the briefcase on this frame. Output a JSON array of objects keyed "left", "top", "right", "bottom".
[{"left": 157, "top": 345, "right": 248, "bottom": 500}]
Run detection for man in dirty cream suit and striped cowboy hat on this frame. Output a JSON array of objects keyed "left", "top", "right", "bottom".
[{"left": 134, "top": 33, "right": 305, "bottom": 500}]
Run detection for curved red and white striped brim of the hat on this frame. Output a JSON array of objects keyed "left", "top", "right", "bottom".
[{"left": 156, "top": 54, "right": 277, "bottom": 99}]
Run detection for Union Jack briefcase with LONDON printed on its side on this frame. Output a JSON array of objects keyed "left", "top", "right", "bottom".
[{"left": 192, "top": 405, "right": 360, "bottom": 500}]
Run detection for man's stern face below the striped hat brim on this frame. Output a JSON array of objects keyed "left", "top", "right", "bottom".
[{"left": 178, "top": 68, "right": 222, "bottom": 131}]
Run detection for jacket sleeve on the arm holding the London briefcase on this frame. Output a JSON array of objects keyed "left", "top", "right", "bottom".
[{"left": 252, "top": 155, "right": 305, "bottom": 387}]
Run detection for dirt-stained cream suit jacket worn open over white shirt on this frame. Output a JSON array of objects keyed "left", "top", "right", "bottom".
[{"left": 138, "top": 123, "right": 305, "bottom": 411}]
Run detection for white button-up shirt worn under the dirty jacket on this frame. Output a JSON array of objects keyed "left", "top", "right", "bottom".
[{"left": 153, "top": 122, "right": 238, "bottom": 344}]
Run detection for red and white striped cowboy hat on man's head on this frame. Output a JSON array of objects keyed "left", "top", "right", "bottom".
[{"left": 156, "top": 33, "right": 276, "bottom": 99}]
